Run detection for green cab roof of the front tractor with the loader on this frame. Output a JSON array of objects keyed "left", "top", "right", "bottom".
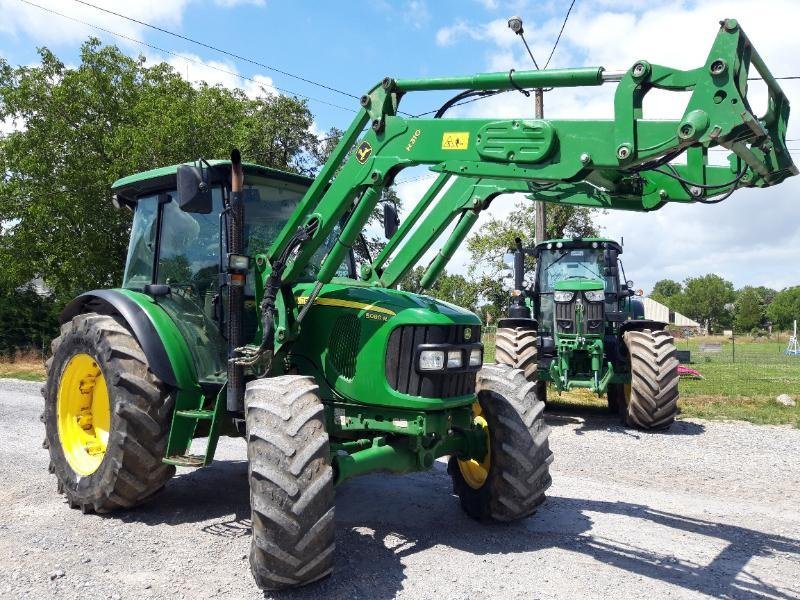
[{"left": 111, "top": 160, "right": 314, "bottom": 204}]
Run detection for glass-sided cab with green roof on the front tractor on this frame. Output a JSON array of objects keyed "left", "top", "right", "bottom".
[{"left": 112, "top": 160, "right": 355, "bottom": 385}]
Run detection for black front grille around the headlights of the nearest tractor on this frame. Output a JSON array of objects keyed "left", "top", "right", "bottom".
[{"left": 385, "top": 325, "right": 481, "bottom": 398}]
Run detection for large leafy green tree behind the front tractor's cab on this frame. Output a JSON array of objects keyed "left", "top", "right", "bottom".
[{"left": 0, "top": 39, "right": 320, "bottom": 303}]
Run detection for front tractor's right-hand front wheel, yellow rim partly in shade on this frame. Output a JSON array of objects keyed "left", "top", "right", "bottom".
[{"left": 447, "top": 365, "right": 553, "bottom": 521}]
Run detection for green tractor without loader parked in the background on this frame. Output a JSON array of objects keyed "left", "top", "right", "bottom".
[{"left": 496, "top": 238, "right": 678, "bottom": 429}]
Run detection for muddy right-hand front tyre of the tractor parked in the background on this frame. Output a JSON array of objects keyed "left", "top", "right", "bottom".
[{"left": 623, "top": 329, "right": 678, "bottom": 429}]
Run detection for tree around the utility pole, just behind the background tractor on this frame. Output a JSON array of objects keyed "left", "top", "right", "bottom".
[{"left": 467, "top": 201, "right": 598, "bottom": 314}]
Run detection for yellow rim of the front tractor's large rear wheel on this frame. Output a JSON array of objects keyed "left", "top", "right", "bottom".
[{"left": 56, "top": 354, "right": 111, "bottom": 475}]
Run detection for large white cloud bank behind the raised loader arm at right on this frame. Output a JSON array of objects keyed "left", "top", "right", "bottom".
[{"left": 437, "top": 0, "right": 800, "bottom": 290}]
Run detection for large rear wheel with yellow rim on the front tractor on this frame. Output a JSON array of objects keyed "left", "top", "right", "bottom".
[{"left": 42, "top": 313, "right": 175, "bottom": 512}]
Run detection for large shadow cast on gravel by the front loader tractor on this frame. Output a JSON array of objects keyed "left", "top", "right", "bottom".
[{"left": 101, "top": 454, "right": 800, "bottom": 600}]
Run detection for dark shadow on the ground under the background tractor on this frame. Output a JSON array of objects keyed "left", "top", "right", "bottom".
[{"left": 545, "top": 404, "right": 706, "bottom": 439}]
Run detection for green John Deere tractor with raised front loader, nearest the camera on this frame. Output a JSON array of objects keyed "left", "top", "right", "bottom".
[{"left": 42, "top": 20, "right": 797, "bottom": 589}]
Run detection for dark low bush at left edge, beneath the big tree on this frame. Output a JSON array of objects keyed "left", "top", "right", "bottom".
[{"left": 0, "top": 286, "right": 58, "bottom": 357}]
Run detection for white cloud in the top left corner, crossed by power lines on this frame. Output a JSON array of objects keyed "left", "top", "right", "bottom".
[{"left": 0, "top": 0, "right": 190, "bottom": 44}]
